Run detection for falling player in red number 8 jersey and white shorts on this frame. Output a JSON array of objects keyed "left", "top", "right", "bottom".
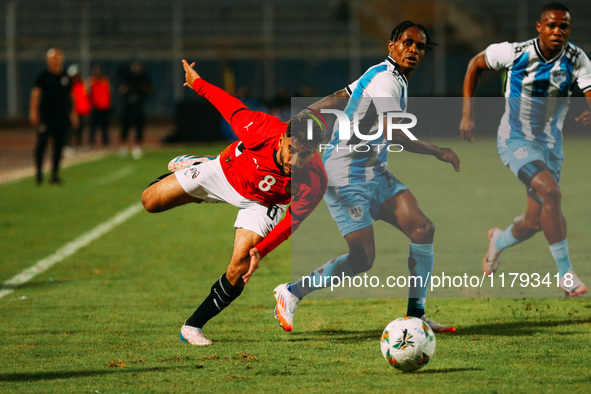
[{"left": 142, "top": 60, "right": 327, "bottom": 345}]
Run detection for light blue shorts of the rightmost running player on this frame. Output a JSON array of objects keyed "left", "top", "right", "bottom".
[{"left": 497, "top": 138, "right": 564, "bottom": 186}]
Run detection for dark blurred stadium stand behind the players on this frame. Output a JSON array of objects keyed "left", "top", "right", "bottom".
[{"left": 0, "top": 0, "right": 591, "bottom": 122}]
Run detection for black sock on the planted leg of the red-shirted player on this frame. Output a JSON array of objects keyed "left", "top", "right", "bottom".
[{"left": 185, "top": 273, "right": 244, "bottom": 328}]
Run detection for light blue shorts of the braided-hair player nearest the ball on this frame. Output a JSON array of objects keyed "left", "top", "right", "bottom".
[{"left": 324, "top": 171, "right": 408, "bottom": 237}]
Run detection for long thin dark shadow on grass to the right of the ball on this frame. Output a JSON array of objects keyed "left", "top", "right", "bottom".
[{"left": 450, "top": 318, "right": 591, "bottom": 336}]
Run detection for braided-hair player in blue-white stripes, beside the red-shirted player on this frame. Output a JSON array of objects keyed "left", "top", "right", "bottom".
[{"left": 275, "top": 21, "right": 460, "bottom": 332}]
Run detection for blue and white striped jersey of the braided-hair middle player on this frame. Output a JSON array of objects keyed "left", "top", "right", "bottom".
[{"left": 322, "top": 57, "right": 408, "bottom": 186}]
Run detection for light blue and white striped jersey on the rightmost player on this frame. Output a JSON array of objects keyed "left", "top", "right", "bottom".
[{"left": 484, "top": 38, "right": 591, "bottom": 152}]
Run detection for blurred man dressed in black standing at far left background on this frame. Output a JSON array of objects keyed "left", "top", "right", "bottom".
[{"left": 29, "top": 48, "right": 78, "bottom": 185}]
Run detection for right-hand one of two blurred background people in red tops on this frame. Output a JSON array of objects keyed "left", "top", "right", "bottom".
[{"left": 90, "top": 65, "right": 111, "bottom": 147}]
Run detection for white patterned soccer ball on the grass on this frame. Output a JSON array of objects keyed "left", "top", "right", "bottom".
[{"left": 380, "top": 316, "right": 435, "bottom": 371}]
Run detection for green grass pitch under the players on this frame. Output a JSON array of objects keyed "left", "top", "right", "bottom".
[{"left": 0, "top": 138, "right": 591, "bottom": 393}]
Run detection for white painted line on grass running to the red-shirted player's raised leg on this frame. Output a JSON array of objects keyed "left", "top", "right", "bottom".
[{"left": 0, "top": 204, "right": 143, "bottom": 298}]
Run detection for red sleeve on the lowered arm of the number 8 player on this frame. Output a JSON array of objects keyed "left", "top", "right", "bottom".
[{"left": 255, "top": 153, "right": 328, "bottom": 258}]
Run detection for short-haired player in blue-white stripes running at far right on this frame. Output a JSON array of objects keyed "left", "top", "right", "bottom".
[{"left": 460, "top": 3, "right": 591, "bottom": 297}]
